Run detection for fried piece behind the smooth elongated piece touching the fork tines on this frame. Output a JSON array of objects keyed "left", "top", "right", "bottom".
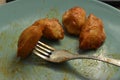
[{"left": 33, "top": 18, "right": 64, "bottom": 40}]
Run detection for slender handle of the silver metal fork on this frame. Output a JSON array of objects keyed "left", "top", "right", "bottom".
[{"left": 73, "top": 55, "right": 120, "bottom": 67}]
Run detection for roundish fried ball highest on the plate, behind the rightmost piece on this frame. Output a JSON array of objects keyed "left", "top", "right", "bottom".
[{"left": 62, "top": 7, "right": 86, "bottom": 35}]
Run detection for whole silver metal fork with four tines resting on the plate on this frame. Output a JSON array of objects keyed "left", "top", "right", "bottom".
[{"left": 32, "top": 41, "right": 120, "bottom": 67}]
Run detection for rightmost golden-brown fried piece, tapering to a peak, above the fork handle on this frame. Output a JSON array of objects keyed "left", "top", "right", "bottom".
[{"left": 79, "top": 14, "right": 106, "bottom": 50}]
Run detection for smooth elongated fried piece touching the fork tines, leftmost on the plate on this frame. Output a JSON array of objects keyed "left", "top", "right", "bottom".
[{"left": 17, "top": 26, "right": 44, "bottom": 58}]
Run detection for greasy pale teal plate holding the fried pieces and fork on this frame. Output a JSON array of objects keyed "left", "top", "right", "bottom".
[{"left": 0, "top": 0, "right": 120, "bottom": 80}]
